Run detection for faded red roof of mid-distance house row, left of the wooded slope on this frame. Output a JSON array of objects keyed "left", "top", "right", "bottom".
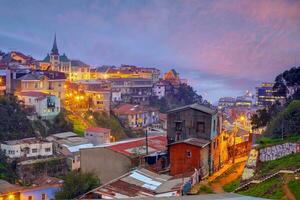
[{"left": 113, "top": 104, "right": 158, "bottom": 115}]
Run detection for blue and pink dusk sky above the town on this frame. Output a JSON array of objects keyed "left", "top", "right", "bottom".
[{"left": 0, "top": 0, "right": 300, "bottom": 102}]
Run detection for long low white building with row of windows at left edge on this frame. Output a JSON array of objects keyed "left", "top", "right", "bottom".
[{"left": 1, "top": 138, "right": 53, "bottom": 158}]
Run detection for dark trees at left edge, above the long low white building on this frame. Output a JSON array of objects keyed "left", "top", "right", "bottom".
[{"left": 0, "top": 96, "right": 35, "bottom": 141}]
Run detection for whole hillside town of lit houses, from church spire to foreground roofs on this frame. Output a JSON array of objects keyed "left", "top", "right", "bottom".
[{"left": 0, "top": 35, "right": 300, "bottom": 200}]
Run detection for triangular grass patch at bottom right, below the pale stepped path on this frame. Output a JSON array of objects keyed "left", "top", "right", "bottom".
[{"left": 238, "top": 177, "right": 284, "bottom": 199}]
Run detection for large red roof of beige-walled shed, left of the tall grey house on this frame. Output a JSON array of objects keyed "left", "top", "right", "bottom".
[{"left": 106, "top": 136, "right": 167, "bottom": 156}]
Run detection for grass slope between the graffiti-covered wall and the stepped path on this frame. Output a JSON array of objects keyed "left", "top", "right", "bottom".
[{"left": 257, "top": 153, "right": 300, "bottom": 176}]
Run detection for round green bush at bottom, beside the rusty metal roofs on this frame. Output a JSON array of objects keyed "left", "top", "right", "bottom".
[{"left": 55, "top": 171, "right": 100, "bottom": 199}]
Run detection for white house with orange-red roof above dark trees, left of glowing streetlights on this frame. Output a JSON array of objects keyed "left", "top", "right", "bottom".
[{"left": 17, "top": 91, "right": 60, "bottom": 119}]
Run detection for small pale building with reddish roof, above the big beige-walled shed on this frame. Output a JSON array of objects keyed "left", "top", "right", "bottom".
[{"left": 84, "top": 127, "right": 110, "bottom": 145}]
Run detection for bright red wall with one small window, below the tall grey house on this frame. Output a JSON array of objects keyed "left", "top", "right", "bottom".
[{"left": 169, "top": 143, "right": 201, "bottom": 176}]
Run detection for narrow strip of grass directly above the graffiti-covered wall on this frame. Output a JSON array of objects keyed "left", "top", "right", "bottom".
[{"left": 256, "top": 135, "right": 300, "bottom": 148}]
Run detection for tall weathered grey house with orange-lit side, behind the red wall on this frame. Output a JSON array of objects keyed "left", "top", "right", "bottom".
[{"left": 167, "top": 103, "right": 222, "bottom": 173}]
